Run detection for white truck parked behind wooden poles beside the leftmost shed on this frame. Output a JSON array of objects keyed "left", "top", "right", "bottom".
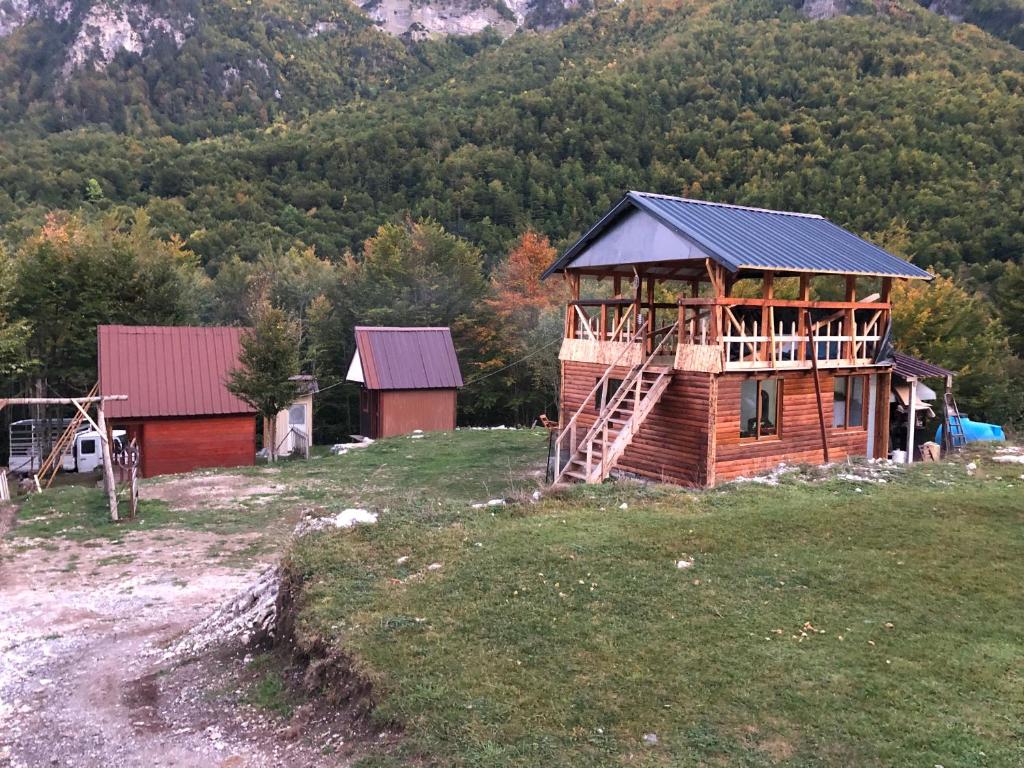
[{"left": 7, "top": 419, "right": 125, "bottom": 475}]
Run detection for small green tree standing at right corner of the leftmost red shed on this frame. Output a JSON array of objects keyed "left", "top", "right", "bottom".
[{"left": 227, "top": 292, "right": 299, "bottom": 461}]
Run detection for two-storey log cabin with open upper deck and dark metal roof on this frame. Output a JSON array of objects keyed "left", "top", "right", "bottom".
[{"left": 544, "top": 191, "right": 931, "bottom": 487}]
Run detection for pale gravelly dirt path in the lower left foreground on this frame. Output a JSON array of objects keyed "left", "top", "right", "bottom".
[{"left": 0, "top": 493, "right": 356, "bottom": 768}]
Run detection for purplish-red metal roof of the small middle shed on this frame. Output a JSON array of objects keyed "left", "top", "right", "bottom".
[{"left": 355, "top": 326, "right": 462, "bottom": 389}]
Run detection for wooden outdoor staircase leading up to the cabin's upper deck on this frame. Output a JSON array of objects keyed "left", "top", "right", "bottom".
[{"left": 554, "top": 323, "right": 679, "bottom": 482}]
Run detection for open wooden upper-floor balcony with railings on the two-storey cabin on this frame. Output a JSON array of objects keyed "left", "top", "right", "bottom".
[{"left": 559, "top": 296, "right": 890, "bottom": 373}]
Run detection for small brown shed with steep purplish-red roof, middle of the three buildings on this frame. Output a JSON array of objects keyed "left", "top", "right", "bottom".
[{"left": 346, "top": 326, "right": 463, "bottom": 439}]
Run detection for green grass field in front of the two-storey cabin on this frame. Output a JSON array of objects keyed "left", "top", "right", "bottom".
[{"left": 9, "top": 431, "right": 1024, "bottom": 768}]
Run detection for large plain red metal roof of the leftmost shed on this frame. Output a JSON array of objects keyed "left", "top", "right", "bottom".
[{"left": 96, "top": 326, "right": 255, "bottom": 419}]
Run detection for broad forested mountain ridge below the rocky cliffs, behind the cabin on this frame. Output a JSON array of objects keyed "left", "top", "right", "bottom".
[{"left": 0, "top": 3, "right": 1024, "bottom": 281}]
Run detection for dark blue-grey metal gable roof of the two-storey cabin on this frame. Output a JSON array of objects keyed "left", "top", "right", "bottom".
[{"left": 544, "top": 191, "right": 932, "bottom": 280}]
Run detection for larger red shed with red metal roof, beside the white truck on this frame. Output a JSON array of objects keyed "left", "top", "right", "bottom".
[{"left": 96, "top": 326, "right": 256, "bottom": 477}]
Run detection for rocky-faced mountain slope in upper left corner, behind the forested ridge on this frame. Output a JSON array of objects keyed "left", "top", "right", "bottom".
[{"left": 0, "top": 0, "right": 418, "bottom": 137}]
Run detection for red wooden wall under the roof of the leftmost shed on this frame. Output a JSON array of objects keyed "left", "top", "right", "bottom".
[{"left": 130, "top": 414, "right": 256, "bottom": 477}]
